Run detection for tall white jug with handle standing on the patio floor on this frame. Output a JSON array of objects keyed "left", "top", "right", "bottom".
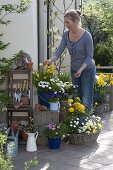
[{"left": 26, "top": 132, "right": 38, "bottom": 152}]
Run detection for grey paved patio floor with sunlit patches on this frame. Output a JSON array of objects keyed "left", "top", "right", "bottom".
[{"left": 13, "top": 112, "right": 113, "bottom": 170}]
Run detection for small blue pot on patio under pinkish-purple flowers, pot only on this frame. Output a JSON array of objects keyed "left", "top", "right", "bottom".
[{"left": 48, "top": 138, "right": 61, "bottom": 149}]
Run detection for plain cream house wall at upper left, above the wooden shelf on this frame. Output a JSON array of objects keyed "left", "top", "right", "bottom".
[{"left": 0, "top": 0, "right": 38, "bottom": 68}]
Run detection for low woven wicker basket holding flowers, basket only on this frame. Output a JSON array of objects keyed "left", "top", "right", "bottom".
[{"left": 69, "top": 132, "right": 100, "bottom": 145}]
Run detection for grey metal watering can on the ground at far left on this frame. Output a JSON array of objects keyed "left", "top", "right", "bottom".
[{"left": 6, "top": 127, "right": 19, "bottom": 157}]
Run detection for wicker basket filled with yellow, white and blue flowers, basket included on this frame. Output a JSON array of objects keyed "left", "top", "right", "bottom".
[{"left": 65, "top": 98, "right": 103, "bottom": 144}]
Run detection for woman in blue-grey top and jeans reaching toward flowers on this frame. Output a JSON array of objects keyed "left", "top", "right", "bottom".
[{"left": 48, "top": 10, "right": 96, "bottom": 112}]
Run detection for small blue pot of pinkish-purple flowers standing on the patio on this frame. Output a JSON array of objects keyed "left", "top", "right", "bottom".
[{"left": 44, "top": 122, "right": 67, "bottom": 149}]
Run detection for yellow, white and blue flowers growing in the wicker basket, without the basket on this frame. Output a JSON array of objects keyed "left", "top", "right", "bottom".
[{"left": 65, "top": 97, "right": 103, "bottom": 134}]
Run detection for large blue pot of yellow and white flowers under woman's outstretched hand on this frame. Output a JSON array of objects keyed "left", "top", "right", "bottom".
[{"left": 33, "top": 64, "right": 64, "bottom": 108}]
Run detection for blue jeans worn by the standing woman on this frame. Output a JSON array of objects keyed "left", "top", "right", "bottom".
[{"left": 71, "top": 66, "right": 96, "bottom": 111}]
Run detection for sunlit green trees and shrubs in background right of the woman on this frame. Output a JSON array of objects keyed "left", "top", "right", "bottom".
[{"left": 83, "top": 0, "right": 113, "bottom": 66}]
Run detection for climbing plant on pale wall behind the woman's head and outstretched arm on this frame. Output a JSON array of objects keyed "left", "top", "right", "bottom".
[{"left": 46, "top": 0, "right": 75, "bottom": 72}]
